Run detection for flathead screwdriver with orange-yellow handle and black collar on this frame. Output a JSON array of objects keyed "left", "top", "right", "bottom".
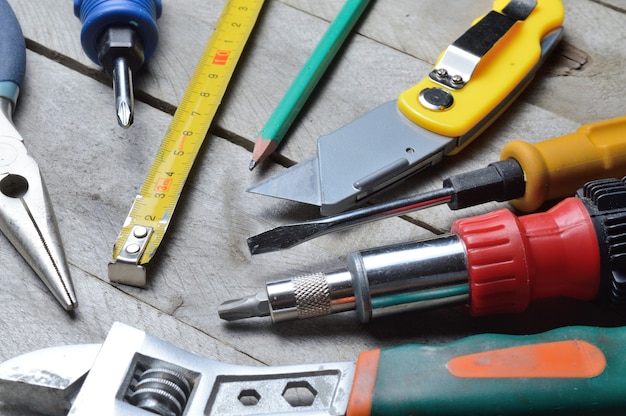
[{"left": 247, "top": 116, "right": 626, "bottom": 254}]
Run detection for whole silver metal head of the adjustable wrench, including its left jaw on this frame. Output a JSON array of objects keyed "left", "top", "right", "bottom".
[{"left": 0, "top": 323, "right": 355, "bottom": 416}]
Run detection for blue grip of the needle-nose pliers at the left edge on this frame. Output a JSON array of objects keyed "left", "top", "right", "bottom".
[{"left": 0, "top": 0, "right": 26, "bottom": 108}]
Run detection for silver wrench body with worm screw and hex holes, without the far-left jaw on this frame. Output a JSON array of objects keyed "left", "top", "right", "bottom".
[{"left": 69, "top": 323, "right": 355, "bottom": 416}]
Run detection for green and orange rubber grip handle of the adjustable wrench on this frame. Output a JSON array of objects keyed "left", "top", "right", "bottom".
[{"left": 347, "top": 327, "right": 626, "bottom": 416}]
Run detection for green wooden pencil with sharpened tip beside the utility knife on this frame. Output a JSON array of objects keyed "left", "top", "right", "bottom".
[{"left": 249, "top": 0, "right": 369, "bottom": 170}]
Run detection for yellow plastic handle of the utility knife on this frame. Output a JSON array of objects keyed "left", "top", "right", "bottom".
[{"left": 398, "top": 0, "right": 564, "bottom": 144}]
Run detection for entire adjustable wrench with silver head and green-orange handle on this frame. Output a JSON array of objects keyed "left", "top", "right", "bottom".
[{"left": 0, "top": 323, "right": 626, "bottom": 416}]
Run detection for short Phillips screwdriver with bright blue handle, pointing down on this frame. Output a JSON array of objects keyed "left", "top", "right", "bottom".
[{"left": 74, "top": 0, "right": 161, "bottom": 128}]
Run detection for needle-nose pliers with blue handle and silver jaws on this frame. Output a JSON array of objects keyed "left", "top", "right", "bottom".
[{"left": 0, "top": 0, "right": 78, "bottom": 311}]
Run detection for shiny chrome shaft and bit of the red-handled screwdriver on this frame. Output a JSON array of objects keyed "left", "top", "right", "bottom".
[{"left": 219, "top": 235, "right": 469, "bottom": 322}]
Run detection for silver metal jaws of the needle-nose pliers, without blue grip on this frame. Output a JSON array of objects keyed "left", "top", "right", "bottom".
[{"left": 0, "top": 97, "right": 78, "bottom": 311}]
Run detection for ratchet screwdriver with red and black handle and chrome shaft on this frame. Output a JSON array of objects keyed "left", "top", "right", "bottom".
[{"left": 218, "top": 179, "right": 626, "bottom": 322}]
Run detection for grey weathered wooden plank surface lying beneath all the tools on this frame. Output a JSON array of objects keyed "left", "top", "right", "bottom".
[{"left": 0, "top": 0, "right": 626, "bottom": 415}]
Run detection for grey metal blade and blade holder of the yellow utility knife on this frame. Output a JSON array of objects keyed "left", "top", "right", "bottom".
[{"left": 248, "top": 101, "right": 456, "bottom": 215}]
